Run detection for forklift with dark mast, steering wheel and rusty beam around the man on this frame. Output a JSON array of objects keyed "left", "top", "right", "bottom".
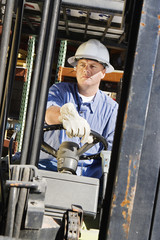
[{"left": 0, "top": 0, "right": 160, "bottom": 240}]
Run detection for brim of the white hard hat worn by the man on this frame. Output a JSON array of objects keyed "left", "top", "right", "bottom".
[{"left": 68, "top": 56, "right": 114, "bottom": 73}]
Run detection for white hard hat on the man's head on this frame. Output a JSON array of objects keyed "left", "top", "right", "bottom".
[{"left": 68, "top": 39, "right": 114, "bottom": 73}]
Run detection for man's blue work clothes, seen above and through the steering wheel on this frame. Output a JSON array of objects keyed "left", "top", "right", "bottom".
[{"left": 39, "top": 82, "right": 118, "bottom": 178}]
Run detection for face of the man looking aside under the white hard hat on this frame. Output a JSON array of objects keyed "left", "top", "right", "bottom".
[{"left": 76, "top": 59, "right": 105, "bottom": 87}]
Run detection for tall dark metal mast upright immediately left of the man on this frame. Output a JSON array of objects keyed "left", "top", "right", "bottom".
[{"left": 21, "top": 0, "right": 61, "bottom": 164}]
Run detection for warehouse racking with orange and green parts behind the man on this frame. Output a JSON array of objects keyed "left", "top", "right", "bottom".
[{"left": 0, "top": 0, "right": 130, "bottom": 155}]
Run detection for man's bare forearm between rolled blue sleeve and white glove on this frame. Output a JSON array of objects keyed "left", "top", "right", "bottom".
[{"left": 45, "top": 106, "right": 61, "bottom": 125}]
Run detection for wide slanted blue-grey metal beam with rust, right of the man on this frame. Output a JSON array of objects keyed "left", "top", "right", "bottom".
[{"left": 100, "top": 0, "right": 160, "bottom": 240}]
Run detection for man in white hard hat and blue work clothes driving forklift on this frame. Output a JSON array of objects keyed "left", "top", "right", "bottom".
[{"left": 39, "top": 39, "right": 118, "bottom": 178}]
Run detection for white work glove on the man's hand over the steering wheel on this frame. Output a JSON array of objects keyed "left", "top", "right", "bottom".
[{"left": 59, "top": 103, "right": 93, "bottom": 143}]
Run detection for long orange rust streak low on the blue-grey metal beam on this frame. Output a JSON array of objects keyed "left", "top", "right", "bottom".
[{"left": 121, "top": 158, "right": 136, "bottom": 239}]
